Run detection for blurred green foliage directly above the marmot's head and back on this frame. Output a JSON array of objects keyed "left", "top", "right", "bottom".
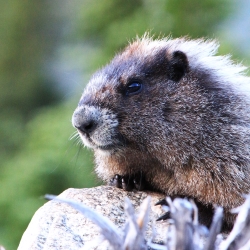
[{"left": 72, "top": 0, "right": 232, "bottom": 66}]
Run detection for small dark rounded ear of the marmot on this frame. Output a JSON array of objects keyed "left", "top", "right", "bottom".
[{"left": 169, "top": 50, "right": 188, "bottom": 82}]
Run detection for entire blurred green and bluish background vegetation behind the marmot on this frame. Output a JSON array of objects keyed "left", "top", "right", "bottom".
[{"left": 0, "top": 0, "right": 250, "bottom": 250}]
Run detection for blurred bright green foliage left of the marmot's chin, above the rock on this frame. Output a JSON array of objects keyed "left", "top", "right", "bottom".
[{"left": 0, "top": 100, "right": 95, "bottom": 249}]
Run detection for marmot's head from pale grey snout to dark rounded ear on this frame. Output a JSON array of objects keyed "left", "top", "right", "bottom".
[{"left": 72, "top": 38, "right": 188, "bottom": 151}]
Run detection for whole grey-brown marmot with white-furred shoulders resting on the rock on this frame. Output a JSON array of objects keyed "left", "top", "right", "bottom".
[{"left": 72, "top": 37, "right": 250, "bottom": 229}]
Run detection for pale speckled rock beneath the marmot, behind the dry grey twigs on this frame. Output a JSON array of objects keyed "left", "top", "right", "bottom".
[{"left": 18, "top": 186, "right": 168, "bottom": 250}]
